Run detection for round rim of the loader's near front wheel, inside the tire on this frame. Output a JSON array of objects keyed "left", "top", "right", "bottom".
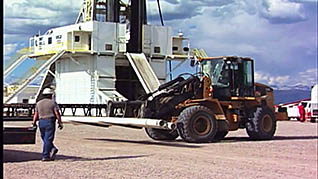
[{"left": 193, "top": 115, "right": 211, "bottom": 136}]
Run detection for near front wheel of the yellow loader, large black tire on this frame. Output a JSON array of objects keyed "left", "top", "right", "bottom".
[{"left": 177, "top": 105, "right": 217, "bottom": 143}]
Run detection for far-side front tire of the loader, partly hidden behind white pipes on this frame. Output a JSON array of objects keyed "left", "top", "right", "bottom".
[{"left": 145, "top": 128, "right": 179, "bottom": 140}]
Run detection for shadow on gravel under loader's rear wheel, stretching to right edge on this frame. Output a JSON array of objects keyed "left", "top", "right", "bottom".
[{"left": 219, "top": 136, "right": 318, "bottom": 143}]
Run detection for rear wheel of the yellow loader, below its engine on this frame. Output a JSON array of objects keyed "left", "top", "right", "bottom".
[{"left": 246, "top": 107, "right": 276, "bottom": 140}]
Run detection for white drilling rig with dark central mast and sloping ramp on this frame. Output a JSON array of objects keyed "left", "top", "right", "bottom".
[{"left": 4, "top": 0, "right": 189, "bottom": 104}]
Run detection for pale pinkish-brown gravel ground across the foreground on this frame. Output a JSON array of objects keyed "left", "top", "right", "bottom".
[{"left": 3, "top": 121, "right": 318, "bottom": 179}]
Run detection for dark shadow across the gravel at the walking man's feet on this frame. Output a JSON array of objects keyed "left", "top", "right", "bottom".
[{"left": 3, "top": 149, "right": 149, "bottom": 163}]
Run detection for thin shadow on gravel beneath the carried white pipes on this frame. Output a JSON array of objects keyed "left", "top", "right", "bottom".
[{"left": 85, "top": 138, "right": 201, "bottom": 148}]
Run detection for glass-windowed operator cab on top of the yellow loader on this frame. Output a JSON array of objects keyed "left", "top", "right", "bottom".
[{"left": 200, "top": 57, "right": 254, "bottom": 100}]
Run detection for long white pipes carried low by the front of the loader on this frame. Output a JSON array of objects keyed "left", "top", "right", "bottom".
[{"left": 62, "top": 116, "right": 175, "bottom": 130}]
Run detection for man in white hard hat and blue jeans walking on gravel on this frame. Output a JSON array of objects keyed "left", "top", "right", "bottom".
[{"left": 32, "top": 88, "right": 63, "bottom": 161}]
